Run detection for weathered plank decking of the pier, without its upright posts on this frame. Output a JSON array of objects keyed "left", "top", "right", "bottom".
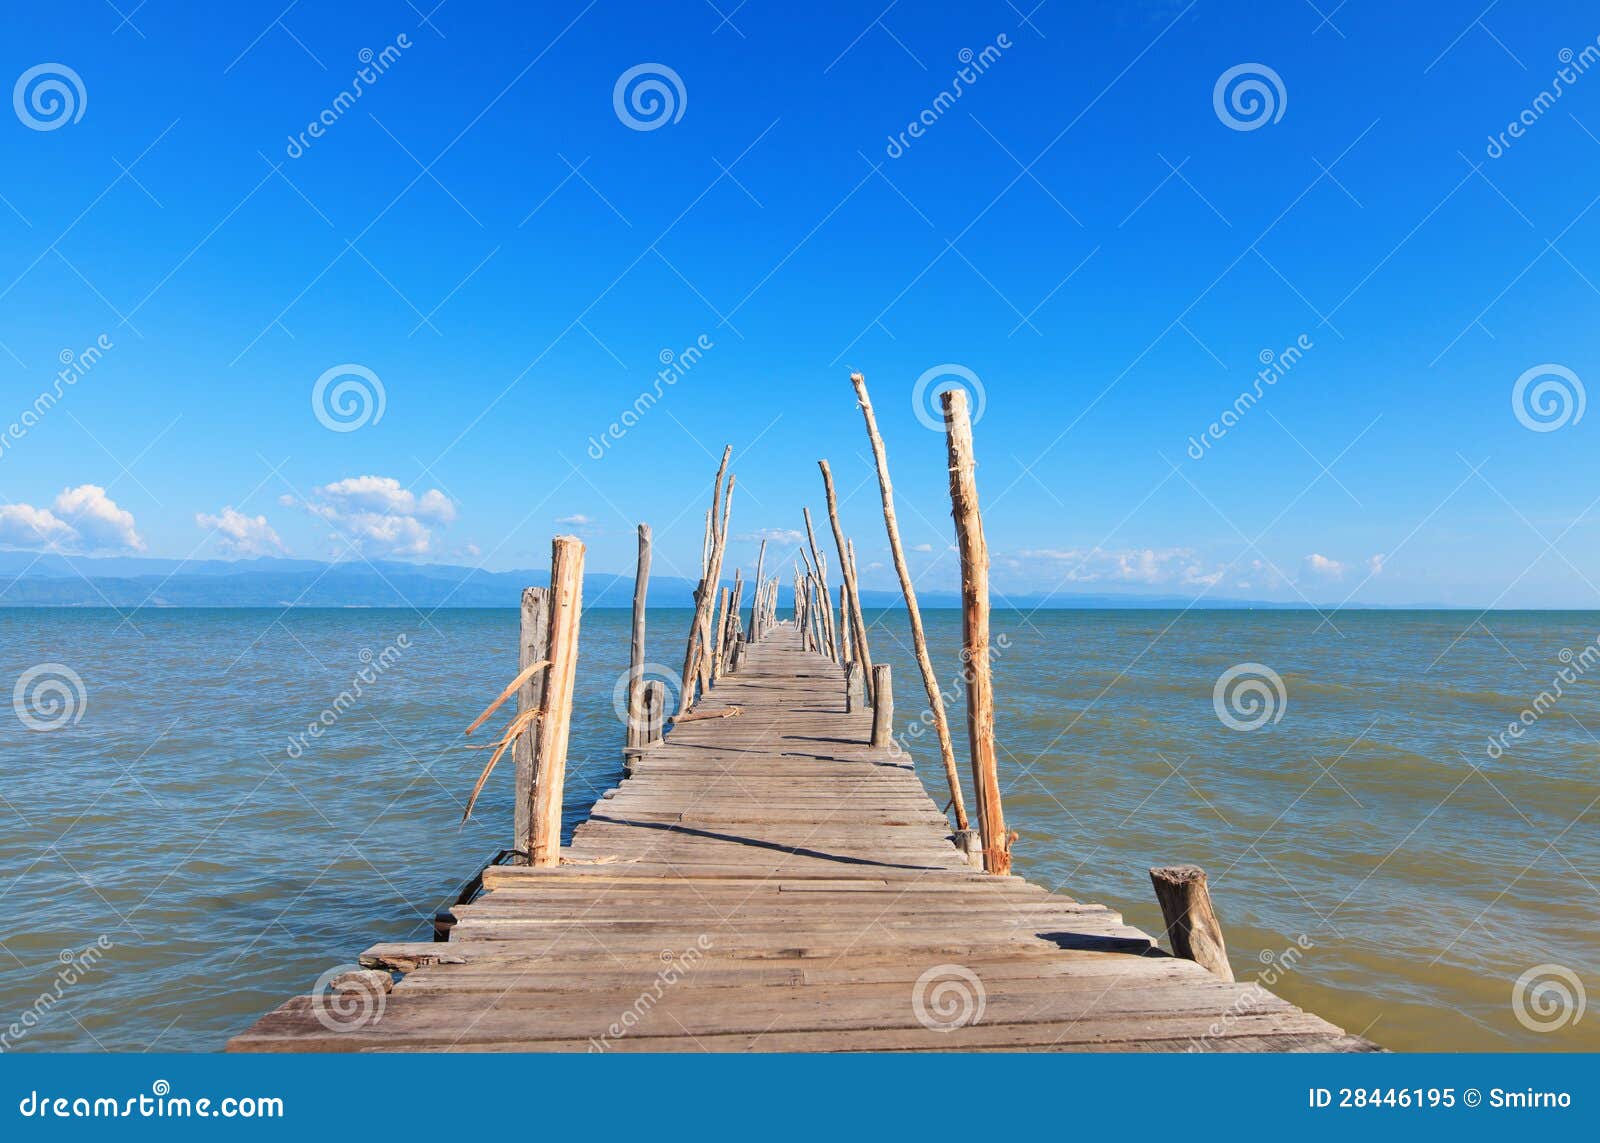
[{"left": 229, "top": 623, "right": 1373, "bottom": 1052}]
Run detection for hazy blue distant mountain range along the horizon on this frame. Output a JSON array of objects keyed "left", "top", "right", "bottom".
[{"left": 0, "top": 551, "right": 1427, "bottom": 613}]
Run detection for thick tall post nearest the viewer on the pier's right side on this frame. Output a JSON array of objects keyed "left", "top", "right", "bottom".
[{"left": 942, "top": 389, "right": 1011, "bottom": 874}]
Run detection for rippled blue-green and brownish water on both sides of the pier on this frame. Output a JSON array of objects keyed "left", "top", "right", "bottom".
[{"left": 0, "top": 610, "right": 1600, "bottom": 1050}]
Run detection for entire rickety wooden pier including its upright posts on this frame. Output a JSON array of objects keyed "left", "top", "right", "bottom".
[{"left": 229, "top": 381, "right": 1374, "bottom": 1052}]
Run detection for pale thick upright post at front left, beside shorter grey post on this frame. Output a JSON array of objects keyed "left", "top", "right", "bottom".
[{"left": 528, "top": 536, "right": 584, "bottom": 866}]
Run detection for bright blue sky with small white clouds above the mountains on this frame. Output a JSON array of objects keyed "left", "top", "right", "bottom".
[{"left": 0, "top": 0, "right": 1600, "bottom": 607}]
